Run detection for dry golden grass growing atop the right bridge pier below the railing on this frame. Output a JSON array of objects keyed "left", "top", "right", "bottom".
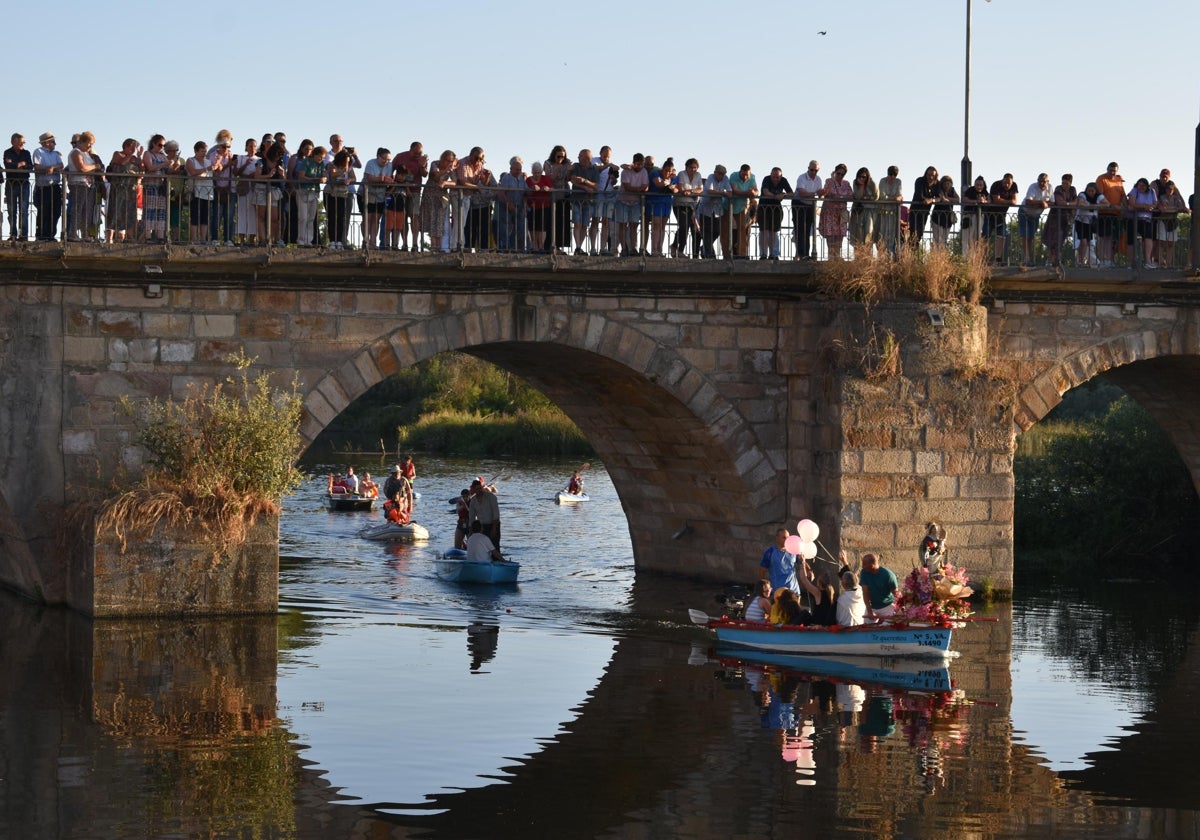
[{"left": 817, "top": 248, "right": 990, "bottom": 306}]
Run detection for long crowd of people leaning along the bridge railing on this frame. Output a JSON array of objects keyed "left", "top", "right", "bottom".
[{"left": 4, "top": 130, "right": 1192, "bottom": 268}]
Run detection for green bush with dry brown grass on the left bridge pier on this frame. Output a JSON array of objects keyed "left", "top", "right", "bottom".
[{"left": 97, "top": 355, "right": 301, "bottom": 557}]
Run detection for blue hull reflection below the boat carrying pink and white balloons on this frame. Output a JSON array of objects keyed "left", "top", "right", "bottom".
[{"left": 715, "top": 647, "right": 953, "bottom": 691}]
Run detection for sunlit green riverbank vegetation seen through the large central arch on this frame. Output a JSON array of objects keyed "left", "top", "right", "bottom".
[{"left": 316, "top": 352, "right": 594, "bottom": 458}]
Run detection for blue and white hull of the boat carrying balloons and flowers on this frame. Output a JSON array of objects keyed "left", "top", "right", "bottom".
[{"left": 709, "top": 620, "right": 952, "bottom": 659}]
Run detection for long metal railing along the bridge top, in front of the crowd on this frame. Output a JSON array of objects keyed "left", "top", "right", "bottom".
[{"left": 0, "top": 165, "right": 1188, "bottom": 268}]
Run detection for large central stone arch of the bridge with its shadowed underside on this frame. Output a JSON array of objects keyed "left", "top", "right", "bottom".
[{"left": 301, "top": 299, "right": 786, "bottom": 580}]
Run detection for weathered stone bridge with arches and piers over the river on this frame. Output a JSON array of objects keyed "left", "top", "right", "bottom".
[{"left": 0, "top": 246, "right": 1200, "bottom": 614}]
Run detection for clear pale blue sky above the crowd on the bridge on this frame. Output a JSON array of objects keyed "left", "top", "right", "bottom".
[{"left": 11, "top": 0, "right": 1200, "bottom": 197}]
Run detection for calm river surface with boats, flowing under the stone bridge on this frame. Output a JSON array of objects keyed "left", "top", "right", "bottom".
[{"left": 0, "top": 458, "right": 1200, "bottom": 840}]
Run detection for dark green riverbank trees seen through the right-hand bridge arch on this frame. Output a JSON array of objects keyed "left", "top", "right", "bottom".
[{"left": 1014, "top": 379, "right": 1200, "bottom": 577}]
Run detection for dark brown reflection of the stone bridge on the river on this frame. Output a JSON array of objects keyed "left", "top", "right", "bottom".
[{"left": 0, "top": 590, "right": 1200, "bottom": 838}]
